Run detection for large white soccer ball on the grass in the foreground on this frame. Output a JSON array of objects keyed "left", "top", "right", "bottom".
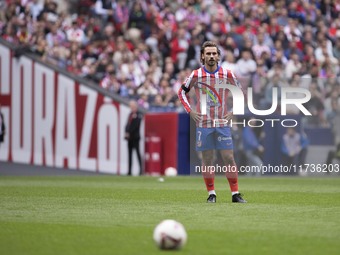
[{"left": 153, "top": 220, "right": 187, "bottom": 250}]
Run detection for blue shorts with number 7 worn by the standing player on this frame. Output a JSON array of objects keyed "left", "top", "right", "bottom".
[{"left": 196, "top": 127, "right": 234, "bottom": 151}]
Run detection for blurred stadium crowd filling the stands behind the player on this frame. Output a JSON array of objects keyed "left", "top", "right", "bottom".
[{"left": 0, "top": 0, "right": 340, "bottom": 130}]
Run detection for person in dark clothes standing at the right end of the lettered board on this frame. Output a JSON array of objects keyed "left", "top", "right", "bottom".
[{"left": 125, "top": 100, "right": 142, "bottom": 175}]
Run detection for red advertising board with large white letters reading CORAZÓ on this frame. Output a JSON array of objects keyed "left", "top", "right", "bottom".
[{"left": 0, "top": 44, "right": 144, "bottom": 174}]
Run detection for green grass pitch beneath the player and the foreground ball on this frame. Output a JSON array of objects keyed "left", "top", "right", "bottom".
[{"left": 0, "top": 175, "right": 340, "bottom": 255}]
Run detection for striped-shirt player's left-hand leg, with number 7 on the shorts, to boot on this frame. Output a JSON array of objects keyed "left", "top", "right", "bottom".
[{"left": 196, "top": 127, "right": 216, "bottom": 203}]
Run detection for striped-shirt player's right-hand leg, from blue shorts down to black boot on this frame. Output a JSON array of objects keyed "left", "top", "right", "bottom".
[{"left": 215, "top": 127, "right": 246, "bottom": 203}]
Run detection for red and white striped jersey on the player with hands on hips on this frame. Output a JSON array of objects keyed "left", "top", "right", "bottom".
[{"left": 178, "top": 66, "right": 242, "bottom": 128}]
